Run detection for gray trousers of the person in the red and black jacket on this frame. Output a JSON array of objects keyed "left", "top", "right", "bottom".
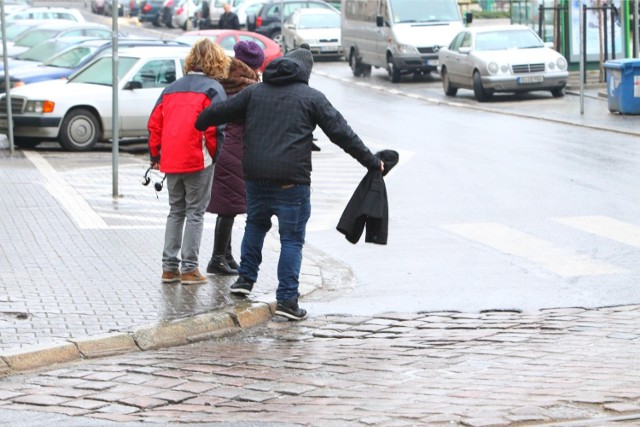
[{"left": 162, "top": 165, "right": 214, "bottom": 273}]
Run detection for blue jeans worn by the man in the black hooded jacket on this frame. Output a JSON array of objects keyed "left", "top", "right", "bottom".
[{"left": 238, "top": 181, "right": 311, "bottom": 301}]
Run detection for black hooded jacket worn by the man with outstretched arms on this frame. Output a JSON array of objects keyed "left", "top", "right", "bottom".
[{"left": 195, "top": 57, "right": 380, "bottom": 185}]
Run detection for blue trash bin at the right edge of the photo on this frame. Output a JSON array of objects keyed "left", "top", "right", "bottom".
[{"left": 604, "top": 59, "right": 640, "bottom": 114}]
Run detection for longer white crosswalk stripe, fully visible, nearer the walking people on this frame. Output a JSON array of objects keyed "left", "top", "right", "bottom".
[{"left": 444, "top": 222, "right": 626, "bottom": 277}]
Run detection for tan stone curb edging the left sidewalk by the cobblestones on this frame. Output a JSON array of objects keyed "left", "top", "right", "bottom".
[{"left": 0, "top": 302, "right": 275, "bottom": 377}]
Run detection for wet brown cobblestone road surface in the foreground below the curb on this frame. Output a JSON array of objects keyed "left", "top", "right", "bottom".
[{"left": 0, "top": 305, "right": 640, "bottom": 426}]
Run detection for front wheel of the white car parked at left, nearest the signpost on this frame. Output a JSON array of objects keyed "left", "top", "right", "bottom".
[{"left": 59, "top": 108, "right": 100, "bottom": 151}]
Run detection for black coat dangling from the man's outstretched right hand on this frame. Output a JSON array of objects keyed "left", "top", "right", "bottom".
[{"left": 336, "top": 150, "right": 400, "bottom": 245}]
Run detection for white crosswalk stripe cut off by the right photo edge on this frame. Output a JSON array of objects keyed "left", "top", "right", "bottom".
[{"left": 554, "top": 215, "right": 640, "bottom": 248}]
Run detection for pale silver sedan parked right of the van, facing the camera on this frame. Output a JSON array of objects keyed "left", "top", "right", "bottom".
[{"left": 438, "top": 25, "right": 569, "bottom": 102}]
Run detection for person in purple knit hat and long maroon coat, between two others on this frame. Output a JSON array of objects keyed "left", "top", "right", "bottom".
[{"left": 207, "top": 41, "right": 264, "bottom": 275}]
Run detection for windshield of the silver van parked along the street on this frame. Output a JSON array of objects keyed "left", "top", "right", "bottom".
[{"left": 390, "top": 0, "right": 460, "bottom": 23}]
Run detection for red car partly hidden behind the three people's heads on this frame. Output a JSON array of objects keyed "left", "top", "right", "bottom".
[{"left": 175, "top": 30, "right": 282, "bottom": 72}]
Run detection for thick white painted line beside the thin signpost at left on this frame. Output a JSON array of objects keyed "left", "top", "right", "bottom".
[{"left": 23, "top": 151, "right": 109, "bottom": 229}]
